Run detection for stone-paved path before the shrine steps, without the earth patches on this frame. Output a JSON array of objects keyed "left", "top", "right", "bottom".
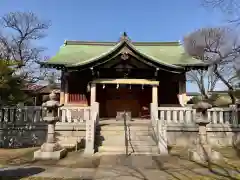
[{"left": 0, "top": 155, "right": 240, "bottom": 180}]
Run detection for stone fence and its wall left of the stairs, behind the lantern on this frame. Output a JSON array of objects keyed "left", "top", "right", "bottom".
[{"left": 0, "top": 106, "right": 90, "bottom": 148}]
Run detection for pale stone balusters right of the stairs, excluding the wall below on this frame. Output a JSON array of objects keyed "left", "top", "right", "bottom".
[{"left": 158, "top": 107, "right": 240, "bottom": 126}]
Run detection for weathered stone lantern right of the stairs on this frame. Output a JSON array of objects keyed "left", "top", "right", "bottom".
[{"left": 189, "top": 101, "right": 221, "bottom": 162}]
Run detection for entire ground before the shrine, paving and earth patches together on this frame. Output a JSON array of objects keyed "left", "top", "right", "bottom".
[{"left": 0, "top": 148, "right": 240, "bottom": 180}]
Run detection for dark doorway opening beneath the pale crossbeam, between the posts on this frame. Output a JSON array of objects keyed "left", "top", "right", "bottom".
[{"left": 97, "top": 84, "right": 152, "bottom": 118}]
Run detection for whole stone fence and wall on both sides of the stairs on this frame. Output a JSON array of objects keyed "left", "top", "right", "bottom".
[{"left": 0, "top": 103, "right": 240, "bottom": 148}]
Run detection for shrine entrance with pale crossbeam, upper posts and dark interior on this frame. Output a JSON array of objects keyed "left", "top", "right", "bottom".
[{"left": 90, "top": 79, "right": 159, "bottom": 119}]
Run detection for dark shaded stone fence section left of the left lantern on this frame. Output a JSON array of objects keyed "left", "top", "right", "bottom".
[{"left": 0, "top": 106, "right": 46, "bottom": 147}]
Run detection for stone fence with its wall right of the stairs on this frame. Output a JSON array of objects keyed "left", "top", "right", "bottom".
[{"left": 157, "top": 106, "right": 240, "bottom": 146}]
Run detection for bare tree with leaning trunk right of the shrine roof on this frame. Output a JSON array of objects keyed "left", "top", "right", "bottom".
[{"left": 184, "top": 27, "right": 240, "bottom": 103}]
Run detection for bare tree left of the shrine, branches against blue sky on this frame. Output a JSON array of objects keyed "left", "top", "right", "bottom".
[{"left": 0, "top": 12, "right": 50, "bottom": 82}]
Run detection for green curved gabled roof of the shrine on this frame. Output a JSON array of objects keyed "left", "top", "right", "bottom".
[{"left": 45, "top": 33, "right": 206, "bottom": 69}]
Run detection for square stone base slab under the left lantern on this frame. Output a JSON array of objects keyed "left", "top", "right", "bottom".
[{"left": 34, "top": 149, "right": 67, "bottom": 160}]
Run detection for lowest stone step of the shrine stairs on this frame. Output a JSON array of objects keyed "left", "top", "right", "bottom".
[{"left": 98, "top": 145, "right": 159, "bottom": 153}]
